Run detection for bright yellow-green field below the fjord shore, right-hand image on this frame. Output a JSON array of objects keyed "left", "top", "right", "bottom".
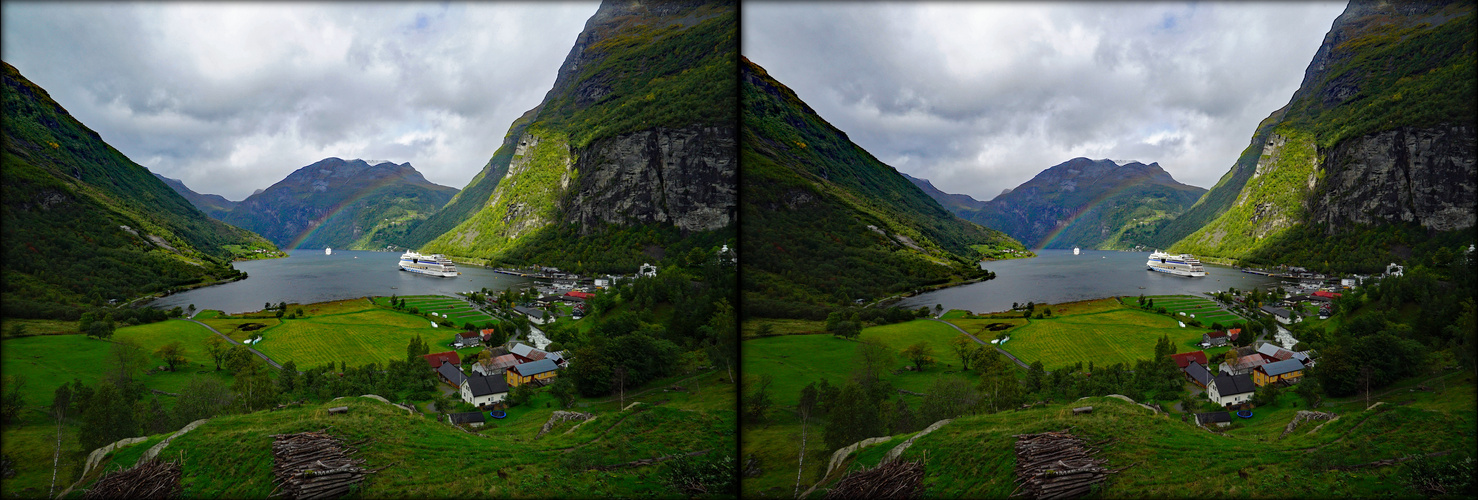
[{"left": 1002, "top": 300, "right": 1206, "bottom": 370}]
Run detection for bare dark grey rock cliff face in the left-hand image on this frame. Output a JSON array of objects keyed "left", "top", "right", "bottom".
[{"left": 565, "top": 126, "right": 738, "bottom": 231}]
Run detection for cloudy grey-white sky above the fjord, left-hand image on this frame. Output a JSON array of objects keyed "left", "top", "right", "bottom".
[{"left": 0, "top": 1, "right": 599, "bottom": 200}]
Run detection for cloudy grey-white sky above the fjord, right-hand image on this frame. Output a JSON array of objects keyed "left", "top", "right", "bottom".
[{"left": 742, "top": 1, "right": 1345, "bottom": 200}]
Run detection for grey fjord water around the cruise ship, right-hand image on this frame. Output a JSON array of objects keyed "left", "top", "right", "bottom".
[{"left": 899, "top": 250, "right": 1278, "bottom": 312}]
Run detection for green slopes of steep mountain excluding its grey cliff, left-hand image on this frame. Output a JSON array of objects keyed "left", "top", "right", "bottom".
[{"left": 406, "top": 1, "right": 738, "bottom": 272}]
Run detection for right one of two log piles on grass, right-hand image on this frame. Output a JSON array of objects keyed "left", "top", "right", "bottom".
[{"left": 1012, "top": 430, "right": 1128, "bottom": 499}]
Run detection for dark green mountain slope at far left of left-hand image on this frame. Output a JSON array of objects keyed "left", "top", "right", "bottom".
[{"left": 0, "top": 64, "right": 275, "bottom": 320}]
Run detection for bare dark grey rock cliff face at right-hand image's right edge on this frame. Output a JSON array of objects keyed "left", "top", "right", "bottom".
[{"left": 1310, "top": 124, "right": 1478, "bottom": 231}]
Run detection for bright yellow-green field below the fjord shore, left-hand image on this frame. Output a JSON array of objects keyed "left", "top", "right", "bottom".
[{"left": 254, "top": 309, "right": 458, "bottom": 368}]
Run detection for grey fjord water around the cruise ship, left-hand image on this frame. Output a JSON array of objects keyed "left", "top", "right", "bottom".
[{"left": 154, "top": 249, "right": 531, "bottom": 312}]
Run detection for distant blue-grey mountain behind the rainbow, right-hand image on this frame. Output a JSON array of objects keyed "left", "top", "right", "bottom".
[{"left": 961, "top": 158, "right": 1206, "bottom": 250}]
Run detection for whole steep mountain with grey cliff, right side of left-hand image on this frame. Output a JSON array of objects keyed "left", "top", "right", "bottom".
[{"left": 408, "top": 0, "right": 738, "bottom": 272}]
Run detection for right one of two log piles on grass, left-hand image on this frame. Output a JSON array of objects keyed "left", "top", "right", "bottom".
[{"left": 272, "top": 432, "right": 378, "bottom": 499}]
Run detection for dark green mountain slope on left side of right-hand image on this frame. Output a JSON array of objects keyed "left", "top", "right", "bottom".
[{"left": 739, "top": 59, "right": 1023, "bottom": 317}]
